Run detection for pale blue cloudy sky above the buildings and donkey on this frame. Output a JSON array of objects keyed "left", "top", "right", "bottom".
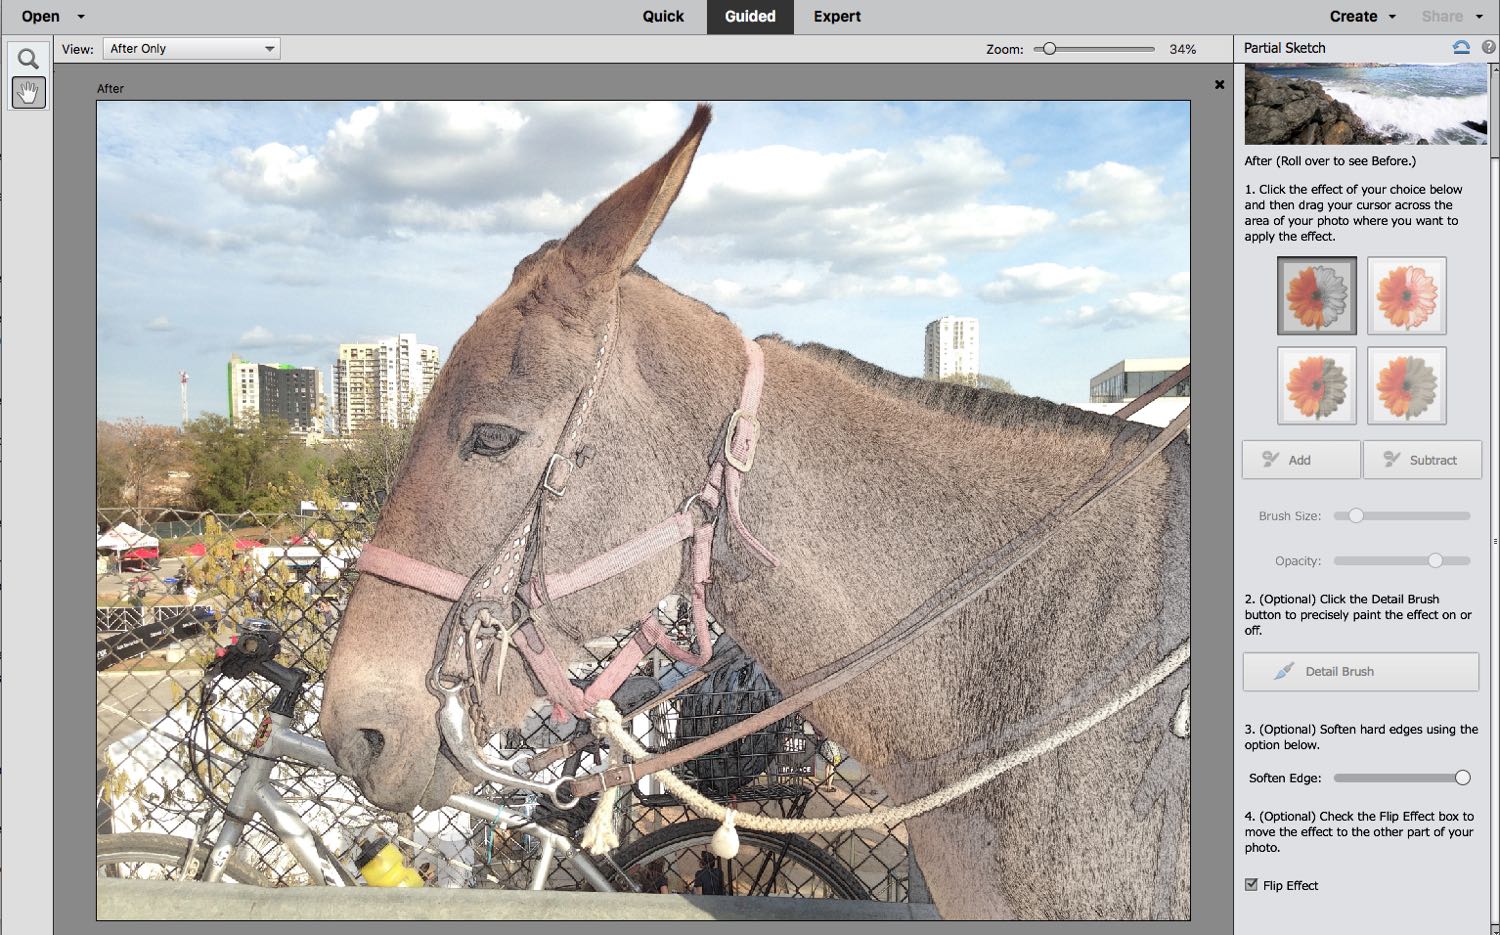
[{"left": 98, "top": 101, "right": 1188, "bottom": 423}]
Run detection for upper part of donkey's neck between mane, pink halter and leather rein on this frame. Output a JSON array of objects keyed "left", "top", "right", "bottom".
[{"left": 744, "top": 342, "right": 1134, "bottom": 663}]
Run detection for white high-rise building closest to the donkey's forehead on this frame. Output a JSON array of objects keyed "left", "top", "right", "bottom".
[{"left": 333, "top": 335, "right": 438, "bottom": 437}]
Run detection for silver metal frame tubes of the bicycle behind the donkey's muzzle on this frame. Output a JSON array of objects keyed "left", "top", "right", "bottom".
[{"left": 203, "top": 714, "right": 615, "bottom": 893}]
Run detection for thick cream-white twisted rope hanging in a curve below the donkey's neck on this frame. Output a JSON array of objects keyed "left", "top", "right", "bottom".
[{"left": 579, "top": 639, "right": 1193, "bottom": 854}]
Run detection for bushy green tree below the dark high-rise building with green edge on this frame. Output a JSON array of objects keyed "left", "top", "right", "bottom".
[{"left": 188, "top": 413, "right": 326, "bottom": 513}]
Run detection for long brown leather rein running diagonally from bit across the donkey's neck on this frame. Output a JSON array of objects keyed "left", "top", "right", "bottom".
[{"left": 567, "top": 407, "right": 1191, "bottom": 798}]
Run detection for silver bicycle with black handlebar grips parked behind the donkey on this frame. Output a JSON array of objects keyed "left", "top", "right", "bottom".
[{"left": 95, "top": 618, "right": 872, "bottom": 899}]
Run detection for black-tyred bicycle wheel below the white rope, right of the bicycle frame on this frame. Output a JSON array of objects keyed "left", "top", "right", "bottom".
[{"left": 612, "top": 818, "right": 873, "bottom": 899}]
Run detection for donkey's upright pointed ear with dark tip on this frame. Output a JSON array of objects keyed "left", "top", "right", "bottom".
[{"left": 563, "top": 104, "right": 713, "bottom": 275}]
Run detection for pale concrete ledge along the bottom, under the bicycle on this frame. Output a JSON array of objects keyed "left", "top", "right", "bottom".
[{"left": 95, "top": 879, "right": 938, "bottom": 921}]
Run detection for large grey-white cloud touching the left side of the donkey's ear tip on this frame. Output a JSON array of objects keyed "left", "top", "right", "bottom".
[{"left": 221, "top": 101, "right": 687, "bottom": 236}]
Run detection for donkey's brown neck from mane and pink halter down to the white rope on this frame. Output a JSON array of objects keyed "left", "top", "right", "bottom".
[{"left": 702, "top": 334, "right": 1166, "bottom": 794}]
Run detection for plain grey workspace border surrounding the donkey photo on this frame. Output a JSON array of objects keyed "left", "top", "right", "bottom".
[{"left": 51, "top": 63, "right": 1241, "bottom": 935}]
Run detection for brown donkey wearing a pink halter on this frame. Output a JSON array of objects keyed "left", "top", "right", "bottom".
[{"left": 321, "top": 107, "right": 1190, "bottom": 918}]
